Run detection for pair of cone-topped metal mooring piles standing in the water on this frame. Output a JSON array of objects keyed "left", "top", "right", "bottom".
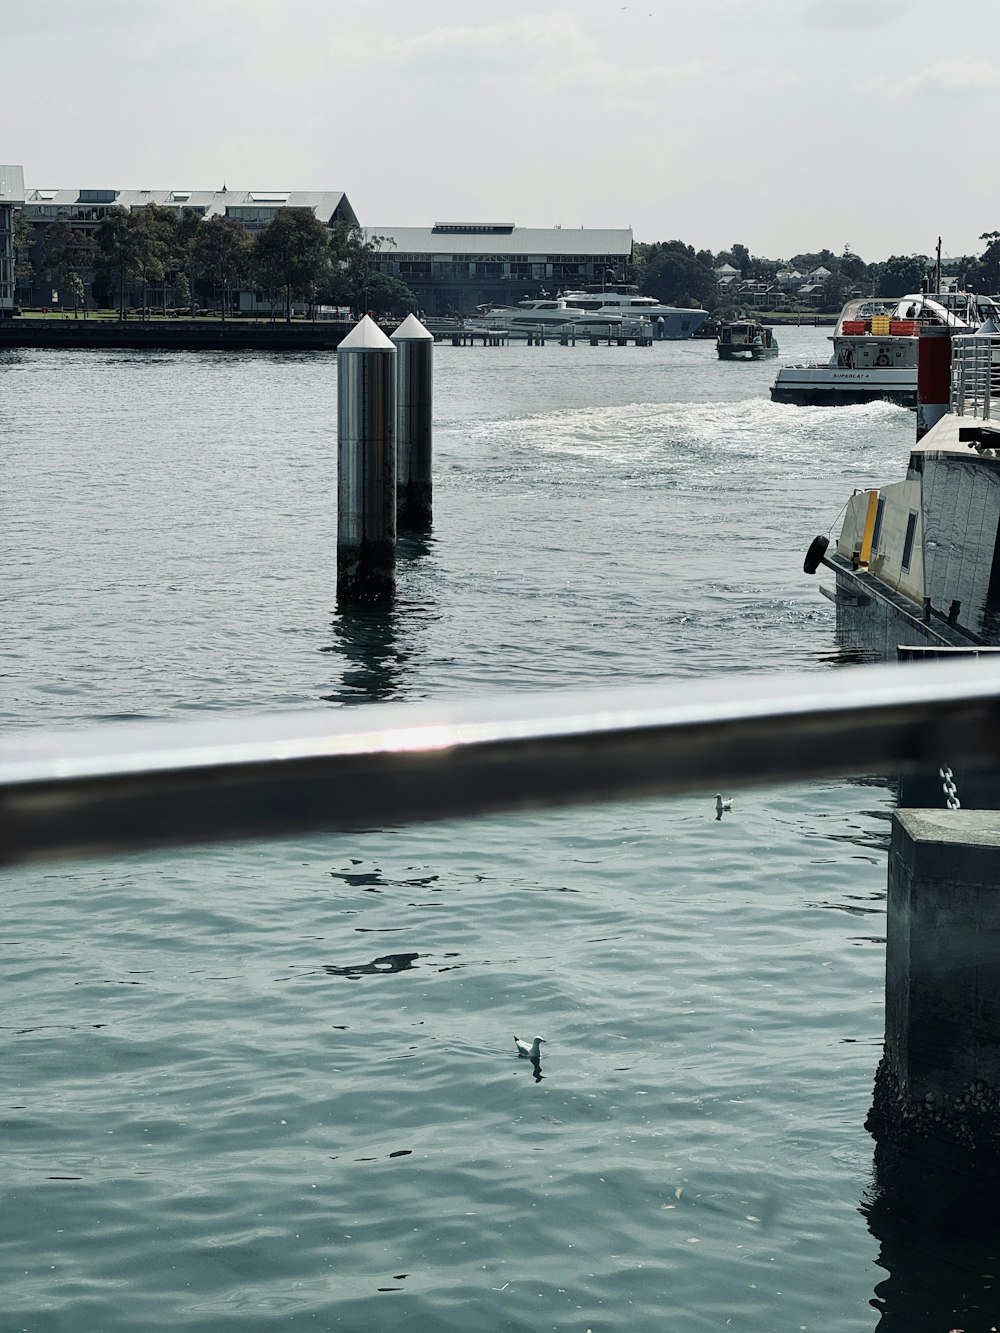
[{"left": 337, "top": 315, "right": 433, "bottom": 605}]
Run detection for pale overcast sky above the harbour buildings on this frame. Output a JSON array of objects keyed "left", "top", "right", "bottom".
[{"left": 7, "top": 0, "right": 1000, "bottom": 260}]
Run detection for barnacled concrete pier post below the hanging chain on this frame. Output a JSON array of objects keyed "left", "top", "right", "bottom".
[{"left": 867, "top": 809, "right": 1000, "bottom": 1225}]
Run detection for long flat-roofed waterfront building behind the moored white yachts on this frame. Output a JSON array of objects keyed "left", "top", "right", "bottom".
[{"left": 365, "top": 223, "right": 632, "bottom": 315}]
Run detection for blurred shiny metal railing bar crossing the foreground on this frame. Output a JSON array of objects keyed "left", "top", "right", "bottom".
[{"left": 0, "top": 657, "right": 1000, "bottom": 865}]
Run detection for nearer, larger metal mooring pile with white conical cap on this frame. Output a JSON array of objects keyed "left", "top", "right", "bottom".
[{"left": 337, "top": 315, "right": 396, "bottom": 605}]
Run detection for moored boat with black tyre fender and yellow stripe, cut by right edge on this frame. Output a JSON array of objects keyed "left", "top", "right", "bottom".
[{"left": 803, "top": 321, "right": 1000, "bottom": 660}]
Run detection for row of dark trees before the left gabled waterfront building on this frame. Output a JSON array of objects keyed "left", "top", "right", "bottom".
[{"left": 15, "top": 204, "right": 416, "bottom": 320}]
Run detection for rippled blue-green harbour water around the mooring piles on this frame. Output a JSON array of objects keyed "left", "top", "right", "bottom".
[{"left": 0, "top": 329, "right": 999, "bottom": 1333}]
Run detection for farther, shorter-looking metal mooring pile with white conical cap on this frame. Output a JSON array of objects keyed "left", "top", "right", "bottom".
[{"left": 392, "top": 315, "right": 435, "bottom": 532}]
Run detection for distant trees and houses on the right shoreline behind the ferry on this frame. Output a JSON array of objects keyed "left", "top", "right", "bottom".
[{"left": 633, "top": 232, "right": 1000, "bottom": 311}]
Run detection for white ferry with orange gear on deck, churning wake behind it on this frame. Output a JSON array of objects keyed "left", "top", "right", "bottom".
[{"left": 771, "top": 292, "right": 1000, "bottom": 408}]
